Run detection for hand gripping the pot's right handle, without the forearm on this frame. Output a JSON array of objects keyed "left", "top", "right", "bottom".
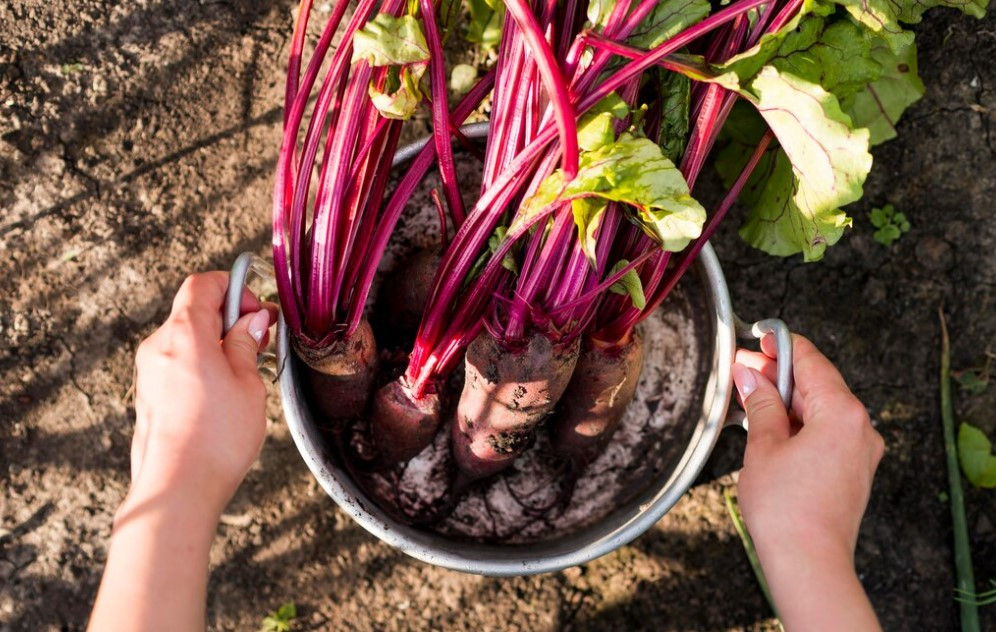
[{"left": 733, "top": 335, "right": 884, "bottom": 564}]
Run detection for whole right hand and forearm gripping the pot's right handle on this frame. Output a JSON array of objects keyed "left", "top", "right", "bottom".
[{"left": 733, "top": 335, "right": 884, "bottom": 630}]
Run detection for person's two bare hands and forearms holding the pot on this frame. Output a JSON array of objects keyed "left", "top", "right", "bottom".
[{"left": 89, "top": 272, "right": 883, "bottom": 631}]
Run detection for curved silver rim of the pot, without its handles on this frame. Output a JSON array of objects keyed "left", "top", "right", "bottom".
[{"left": 277, "top": 244, "right": 736, "bottom": 577}]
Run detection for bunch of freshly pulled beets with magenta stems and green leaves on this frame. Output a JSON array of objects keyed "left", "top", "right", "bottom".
[{"left": 273, "top": 0, "right": 987, "bottom": 512}]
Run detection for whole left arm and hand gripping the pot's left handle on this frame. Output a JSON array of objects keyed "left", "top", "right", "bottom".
[{"left": 89, "top": 272, "right": 276, "bottom": 631}]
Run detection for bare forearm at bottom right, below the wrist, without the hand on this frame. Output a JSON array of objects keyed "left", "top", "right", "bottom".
[{"left": 758, "top": 541, "right": 881, "bottom": 632}]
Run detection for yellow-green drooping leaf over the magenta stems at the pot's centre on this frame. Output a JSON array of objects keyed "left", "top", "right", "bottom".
[{"left": 509, "top": 133, "right": 706, "bottom": 251}]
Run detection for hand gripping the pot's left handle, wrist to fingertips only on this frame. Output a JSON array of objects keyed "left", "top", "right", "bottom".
[{"left": 125, "top": 272, "right": 277, "bottom": 515}]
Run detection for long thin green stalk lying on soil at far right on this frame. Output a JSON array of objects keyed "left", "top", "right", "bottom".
[{"left": 937, "top": 308, "right": 979, "bottom": 632}]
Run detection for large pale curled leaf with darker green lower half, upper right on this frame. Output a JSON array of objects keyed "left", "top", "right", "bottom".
[{"left": 740, "top": 66, "right": 872, "bottom": 261}]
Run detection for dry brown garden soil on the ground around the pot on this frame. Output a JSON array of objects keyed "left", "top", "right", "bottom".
[{"left": 0, "top": 0, "right": 996, "bottom": 630}]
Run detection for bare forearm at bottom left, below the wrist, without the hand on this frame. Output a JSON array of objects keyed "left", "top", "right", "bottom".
[{"left": 89, "top": 493, "right": 217, "bottom": 632}]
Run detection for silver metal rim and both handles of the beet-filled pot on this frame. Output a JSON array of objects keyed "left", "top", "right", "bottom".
[{"left": 225, "top": 125, "right": 792, "bottom": 577}]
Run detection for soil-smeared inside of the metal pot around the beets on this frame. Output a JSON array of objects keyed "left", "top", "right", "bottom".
[{"left": 304, "top": 152, "right": 714, "bottom": 543}]
